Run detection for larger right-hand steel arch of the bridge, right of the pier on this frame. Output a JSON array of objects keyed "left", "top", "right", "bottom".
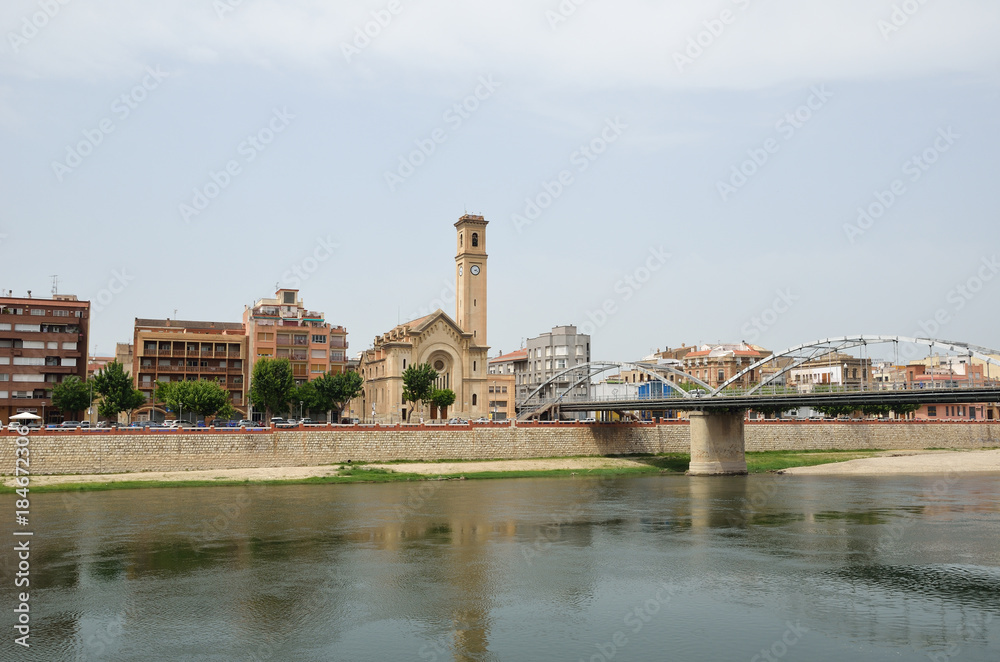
[{"left": 710, "top": 335, "right": 1000, "bottom": 396}]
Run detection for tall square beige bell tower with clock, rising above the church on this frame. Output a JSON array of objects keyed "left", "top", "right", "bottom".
[{"left": 455, "top": 214, "right": 489, "bottom": 347}]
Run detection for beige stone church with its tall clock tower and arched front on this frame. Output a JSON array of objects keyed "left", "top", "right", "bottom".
[{"left": 353, "top": 214, "right": 489, "bottom": 423}]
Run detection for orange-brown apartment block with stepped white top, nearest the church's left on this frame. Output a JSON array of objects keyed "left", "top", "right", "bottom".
[{"left": 243, "top": 290, "right": 347, "bottom": 384}]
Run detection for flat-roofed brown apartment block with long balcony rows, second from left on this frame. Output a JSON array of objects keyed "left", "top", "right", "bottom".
[{"left": 126, "top": 319, "right": 248, "bottom": 421}]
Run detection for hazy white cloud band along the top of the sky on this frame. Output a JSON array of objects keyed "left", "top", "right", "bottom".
[{"left": 0, "top": 0, "right": 1000, "bottom": 91}]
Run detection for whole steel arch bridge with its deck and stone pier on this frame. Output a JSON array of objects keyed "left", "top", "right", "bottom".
[{"left": 517, "top": 335, "right": 1000, "bottom": 474}]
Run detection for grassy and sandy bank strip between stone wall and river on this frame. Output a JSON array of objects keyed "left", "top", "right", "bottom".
[{"left": 0, "top": 450, "right": 881, "bottom": 493}]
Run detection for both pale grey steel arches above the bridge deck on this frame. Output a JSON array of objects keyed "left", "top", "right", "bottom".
[{"left": 516, "top": 335, "right": 1000, "bottom": 420}]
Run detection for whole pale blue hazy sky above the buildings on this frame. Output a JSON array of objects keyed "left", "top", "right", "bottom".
[{"left": 0, "top": 0, "right": 1000, "bottom": 360}]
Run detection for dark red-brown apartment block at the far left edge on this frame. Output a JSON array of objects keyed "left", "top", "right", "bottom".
[{"left": 0, "top": 292, "right": 90, "bottom": 422}]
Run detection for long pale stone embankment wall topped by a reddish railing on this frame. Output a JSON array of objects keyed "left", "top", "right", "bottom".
[{"left": 7, "top": 422, "right": 1000, "bottom": 474}]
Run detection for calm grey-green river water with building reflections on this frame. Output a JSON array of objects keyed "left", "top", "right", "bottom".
[{"left": 0, "top": 475, "right": 1000, "bottom": 662}]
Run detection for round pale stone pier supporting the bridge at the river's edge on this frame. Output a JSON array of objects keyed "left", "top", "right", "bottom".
[{"left": 688, "top": 411, "right": 747, "bottom": 476}]
